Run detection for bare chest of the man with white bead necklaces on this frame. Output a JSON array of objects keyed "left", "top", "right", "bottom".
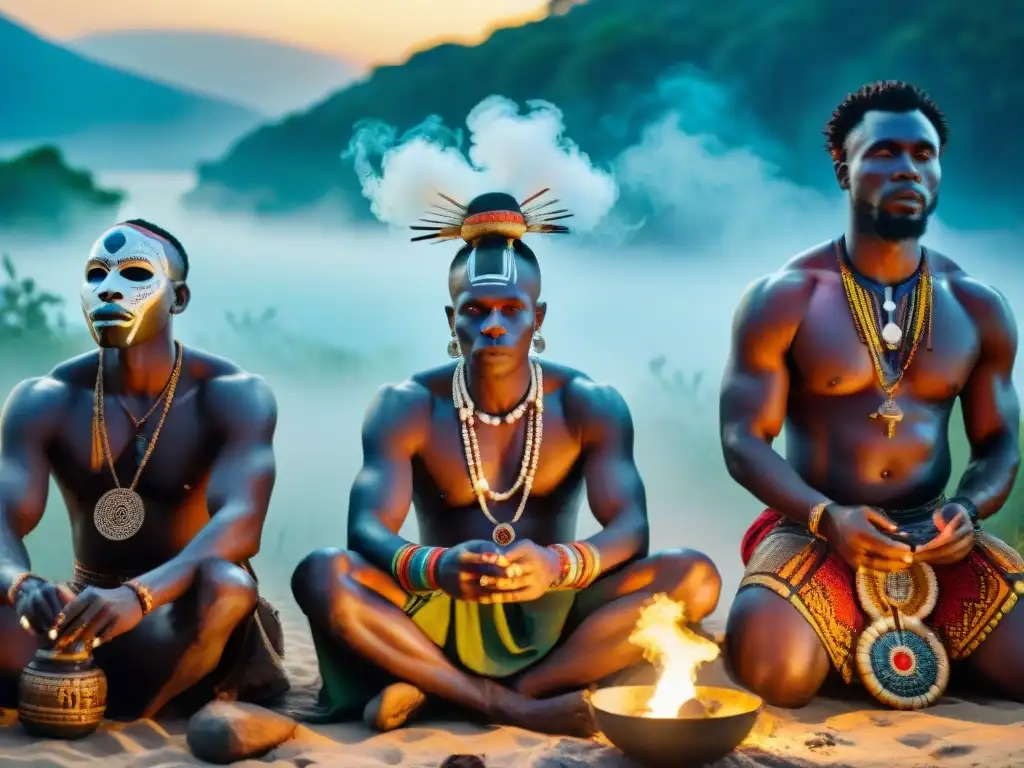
[{"left": 421, "top": 398, "right": 580, "bottom": 507}]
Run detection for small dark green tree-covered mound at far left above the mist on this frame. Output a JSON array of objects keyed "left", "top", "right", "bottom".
[{"left": 0, "top": 146, "right": 124, "bottom": 236}]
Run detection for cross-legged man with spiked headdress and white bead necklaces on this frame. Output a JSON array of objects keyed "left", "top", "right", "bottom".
[{"left": 292, "top": 194, "right": 721, "bottom": 734}]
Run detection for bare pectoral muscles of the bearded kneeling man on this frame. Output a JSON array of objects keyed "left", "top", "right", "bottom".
[{"left": 791, "top": 278, "right": 979, "bottom": 402}]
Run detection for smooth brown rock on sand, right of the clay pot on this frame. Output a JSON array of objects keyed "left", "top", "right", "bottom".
[{"left": 185, "top": 701, "right": 297, "bottom": 765}]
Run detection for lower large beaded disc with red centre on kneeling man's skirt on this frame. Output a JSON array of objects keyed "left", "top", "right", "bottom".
[{"left": 856, "top": 616, "right": 949, "bottom": 710}]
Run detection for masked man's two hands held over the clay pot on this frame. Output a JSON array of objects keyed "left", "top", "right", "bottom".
[{"left": 14, "top": 580, "right": 142, "bottom": 650}]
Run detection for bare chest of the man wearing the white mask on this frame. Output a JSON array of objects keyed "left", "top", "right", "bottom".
[{"left": 50, "top": 389, "right": 217, "bottom": 507}]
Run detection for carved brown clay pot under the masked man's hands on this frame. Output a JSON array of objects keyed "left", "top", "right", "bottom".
[{"left": 17, "top": 650, "right": 106, "bottom": 739}]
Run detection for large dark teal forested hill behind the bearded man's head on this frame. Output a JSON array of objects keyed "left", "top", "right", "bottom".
[{"left": 187, "top": 0, "right": 1024, "bottom": 234}]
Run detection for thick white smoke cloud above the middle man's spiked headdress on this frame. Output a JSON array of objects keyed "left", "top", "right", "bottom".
[{"left": 345, "top": 96, "right": 618, "bottom": 231}]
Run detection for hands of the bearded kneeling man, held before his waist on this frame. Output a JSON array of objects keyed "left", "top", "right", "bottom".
[{"left": 825, "top": 502, "right": 974, "bottom": 571}]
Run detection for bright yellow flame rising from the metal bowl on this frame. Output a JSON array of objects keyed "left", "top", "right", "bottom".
[{"left": 630, "top": 594, "right": 721, "bottom": 718}]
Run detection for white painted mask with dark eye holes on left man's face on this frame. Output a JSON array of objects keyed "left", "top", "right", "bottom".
[{"left": 82, "top": 224, "right": 181, "bottom": 348}]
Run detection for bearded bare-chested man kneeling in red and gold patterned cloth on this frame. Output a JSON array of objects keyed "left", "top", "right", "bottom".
[{"left": 721, "top": 82, "right": 1024, "bottom": 709}]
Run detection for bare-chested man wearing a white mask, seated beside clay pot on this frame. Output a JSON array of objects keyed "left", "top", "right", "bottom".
[{"left": 0, "top": 220, "right": 287, "bottom": 718}]
